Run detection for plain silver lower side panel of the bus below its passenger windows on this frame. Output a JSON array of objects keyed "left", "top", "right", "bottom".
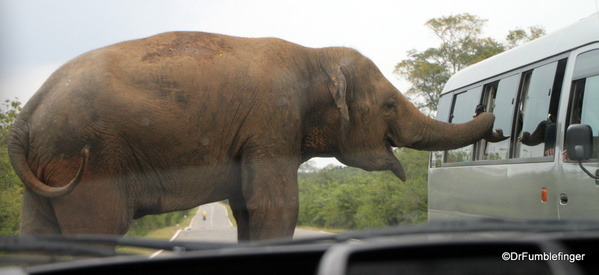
[{"left": 428, "top": 162, "right": 559, "bottom": 221}]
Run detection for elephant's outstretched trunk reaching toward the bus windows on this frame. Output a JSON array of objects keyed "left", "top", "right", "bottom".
[{"left": 404, "top": 107, "right": 495, "bottom": 151}]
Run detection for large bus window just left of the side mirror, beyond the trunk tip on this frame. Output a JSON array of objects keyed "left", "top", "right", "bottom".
[{"left": 513, "top": 60, "right": 566, "bottom": 158}]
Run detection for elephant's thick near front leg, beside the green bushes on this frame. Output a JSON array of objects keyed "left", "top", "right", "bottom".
[{"left": 242, "top": 153, "right": 299, "bottom": 241}]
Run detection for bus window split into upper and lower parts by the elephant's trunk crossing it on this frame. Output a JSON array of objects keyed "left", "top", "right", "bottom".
[{"left": 446, "top": 86, "right": 482, "bottom": 163}]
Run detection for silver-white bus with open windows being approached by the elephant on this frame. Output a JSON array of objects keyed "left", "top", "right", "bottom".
[{"left": 428, "top": 13, "right": 599, "bottom": 220}]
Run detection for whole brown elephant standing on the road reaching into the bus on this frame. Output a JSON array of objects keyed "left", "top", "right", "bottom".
[{"left": 8, "top": 32, "right": 501, "bottom": 241}]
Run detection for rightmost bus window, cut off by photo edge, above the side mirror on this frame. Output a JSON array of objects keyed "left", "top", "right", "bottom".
[{"left": 568, "top": 50, "right": 599, "bottom": 158}]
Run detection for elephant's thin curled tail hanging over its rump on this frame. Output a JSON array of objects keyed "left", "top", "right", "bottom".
[{"left": 8, "top": 119, "right": 89, "bottom": 198}]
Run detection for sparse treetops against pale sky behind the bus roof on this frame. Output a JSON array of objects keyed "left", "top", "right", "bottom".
[{"left": 394, "top": 13, "right": 545, "bottom": 115}]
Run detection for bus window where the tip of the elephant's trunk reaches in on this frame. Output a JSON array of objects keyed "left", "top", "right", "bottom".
[{"left": 477, "top": 75, "right": 519, "bottom": 160}]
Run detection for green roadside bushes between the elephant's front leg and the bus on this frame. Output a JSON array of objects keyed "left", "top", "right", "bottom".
[{"left": 298, "top": 148, "right": 428, "bottom": 230}]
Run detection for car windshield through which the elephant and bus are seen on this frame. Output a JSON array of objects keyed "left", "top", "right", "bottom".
[{"left": 0, "top": 0, "right": 599, "bottom": 272}]
